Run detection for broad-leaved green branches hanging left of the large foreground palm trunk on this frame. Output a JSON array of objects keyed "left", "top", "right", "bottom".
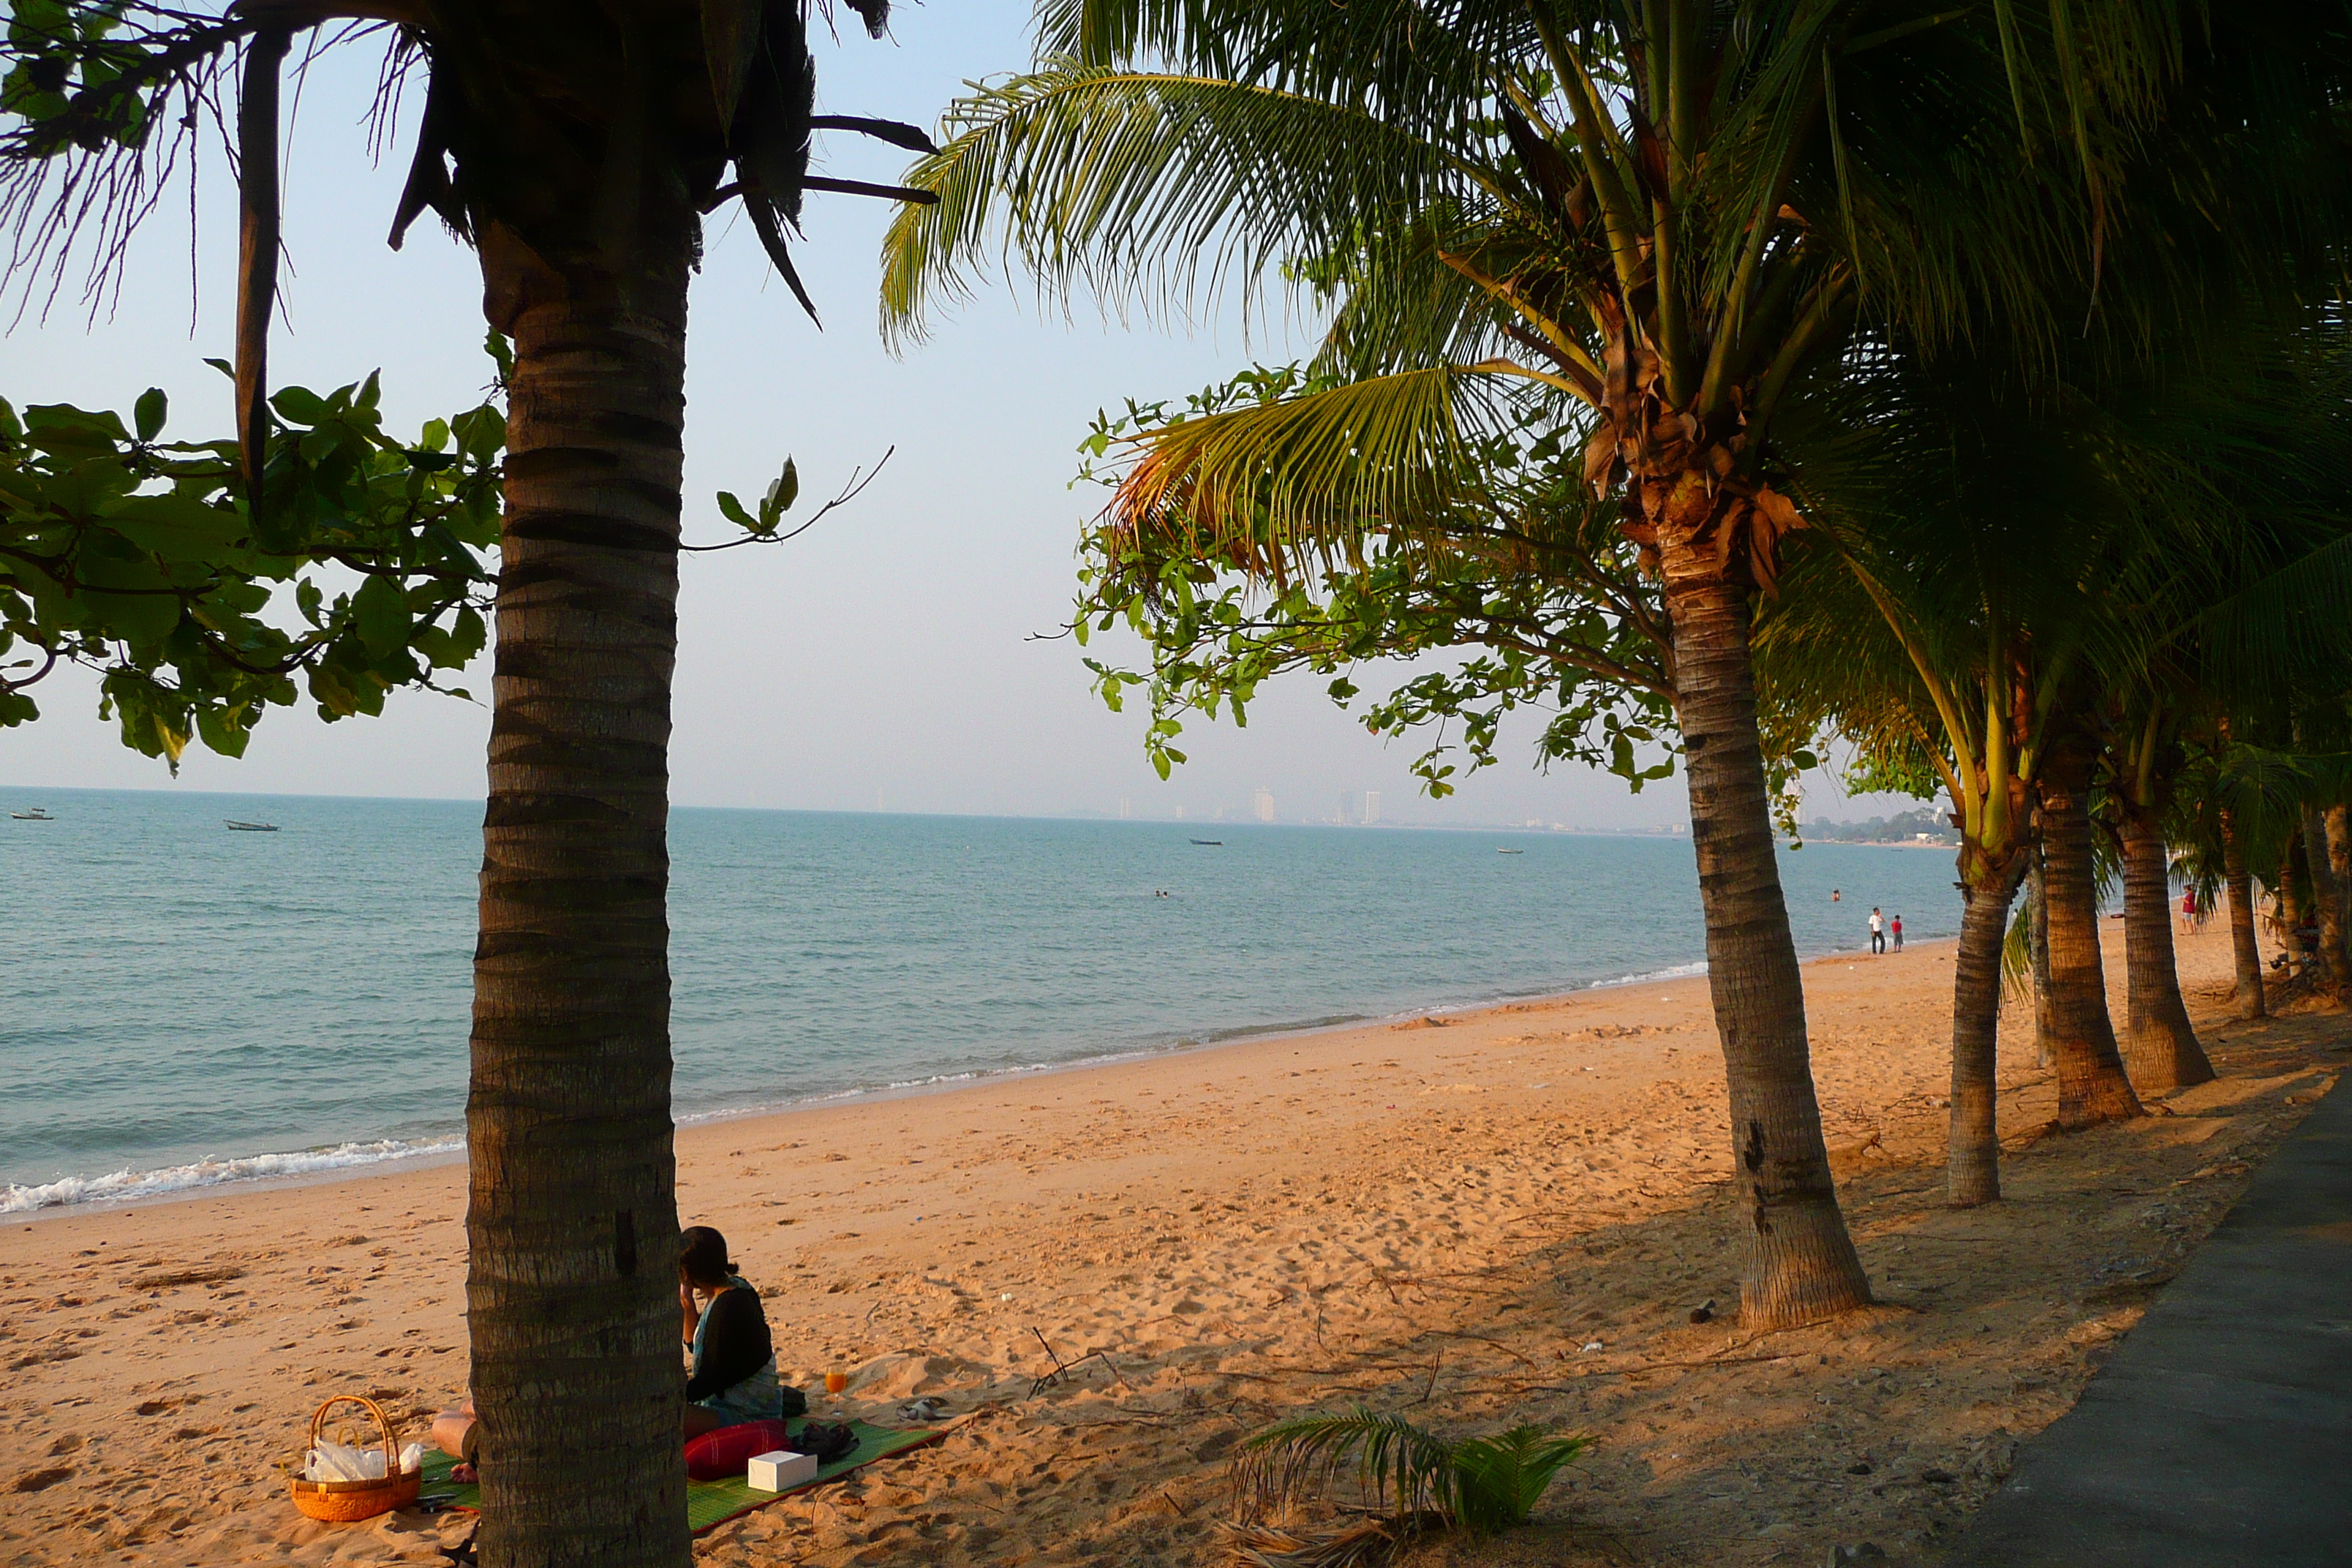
[{"left": 0, "top": 376, "right": 505, "bottom": 766}]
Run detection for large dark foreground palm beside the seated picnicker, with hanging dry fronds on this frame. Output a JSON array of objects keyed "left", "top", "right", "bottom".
[{"left": 0, "top": 0, "right": 929, "bottom": 1564}]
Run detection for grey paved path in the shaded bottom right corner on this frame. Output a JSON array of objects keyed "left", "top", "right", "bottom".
[{"left": 1942, "top": 1088, "right": 2352, "bottom": 1568}]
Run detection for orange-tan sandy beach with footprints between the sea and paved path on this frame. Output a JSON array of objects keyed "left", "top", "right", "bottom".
[{"left": 0, "top": 921, "right": 2352, "bottom": 1566}]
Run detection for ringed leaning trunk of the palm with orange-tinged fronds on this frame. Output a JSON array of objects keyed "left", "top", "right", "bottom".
[{"left": 1663, "top": 535, "right": 1870, "bottom": 1328}]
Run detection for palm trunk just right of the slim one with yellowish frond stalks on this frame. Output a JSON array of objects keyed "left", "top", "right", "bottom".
[{"left": 2041, "top": 753, "right": 2141, "bottom": 1126}]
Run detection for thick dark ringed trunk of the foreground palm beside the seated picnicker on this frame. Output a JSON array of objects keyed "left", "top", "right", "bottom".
[{"left": 466, "top": 247, "right": 692, "bottom": 1568}]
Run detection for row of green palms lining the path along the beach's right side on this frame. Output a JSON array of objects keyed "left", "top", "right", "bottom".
[{"left": 884, "top": 0, "right": 2352, "bottom": 1326}]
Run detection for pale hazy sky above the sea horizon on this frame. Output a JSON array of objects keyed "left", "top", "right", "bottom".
[{"left": 0, "top": 0, "right": 1900, "bottom": 825}]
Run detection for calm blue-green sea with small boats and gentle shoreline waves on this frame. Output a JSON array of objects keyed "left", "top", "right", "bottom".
[{"left": 0, "top": 790, "right": 1959, "bottom": 1213}]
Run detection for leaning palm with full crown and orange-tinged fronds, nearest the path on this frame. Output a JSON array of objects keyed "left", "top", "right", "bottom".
[{"left": 884, "top": 0, "right": 2352, "bottom": 1324}]
